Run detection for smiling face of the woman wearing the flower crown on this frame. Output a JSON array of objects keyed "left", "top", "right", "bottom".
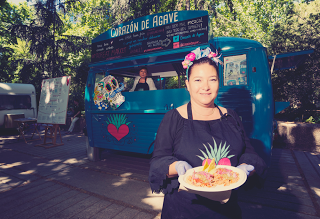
[{"left": 186, "top": 63, "right": 219, "bottom": 106}]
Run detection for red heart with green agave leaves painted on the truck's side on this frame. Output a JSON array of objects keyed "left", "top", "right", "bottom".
[{"left": 106, "top": 114, "right": 131, "bottom": 141}]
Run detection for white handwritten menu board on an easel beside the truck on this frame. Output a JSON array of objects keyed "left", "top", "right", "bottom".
[{"left": 37, "top": 76, "right": 71, "bottom": 124}]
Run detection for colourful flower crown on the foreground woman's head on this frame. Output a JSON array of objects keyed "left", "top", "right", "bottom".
[{"left": 182, "top": 47, "right": 223, "bottom": 78}]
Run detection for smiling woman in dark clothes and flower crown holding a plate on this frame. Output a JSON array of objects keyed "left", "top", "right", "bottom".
[{"left": 149, "top": 48, "right": 266, "bottom": 219}]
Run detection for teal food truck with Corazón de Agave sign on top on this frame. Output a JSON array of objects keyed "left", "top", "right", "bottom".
[{"left": 85, "top": 11, "right": 284, "bottom": 163}]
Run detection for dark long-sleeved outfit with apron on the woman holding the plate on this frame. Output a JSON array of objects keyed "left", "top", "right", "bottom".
[{"left": 149, "top": 103, "right": 266, "bottom": 218}]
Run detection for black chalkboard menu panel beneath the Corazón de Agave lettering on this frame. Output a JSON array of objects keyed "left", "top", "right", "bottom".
[{"left": 91, "top": 15, "right": 208, "bottom": 62}]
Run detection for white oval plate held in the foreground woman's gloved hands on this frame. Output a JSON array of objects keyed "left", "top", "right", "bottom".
[{"left": 178, "top": 165, "right": 247, "bottom": 192}]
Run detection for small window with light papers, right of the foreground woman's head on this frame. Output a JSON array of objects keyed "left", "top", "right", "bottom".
[{"left": 223, "top": 54, "right": 248, "bottom": 86}]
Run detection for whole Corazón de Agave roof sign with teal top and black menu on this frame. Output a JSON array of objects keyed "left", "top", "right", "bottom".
[{"left": 91, "top": 11, "right": 208, "bottom": 62}]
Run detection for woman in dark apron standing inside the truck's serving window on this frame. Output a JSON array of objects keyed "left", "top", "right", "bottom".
[{"left": 130, "top": 67, "right": 157, "bottom": 92}]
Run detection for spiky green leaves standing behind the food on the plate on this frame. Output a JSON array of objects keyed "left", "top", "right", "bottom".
[{"left": 196, "top": 138, "right": 234, "bottom": 163}]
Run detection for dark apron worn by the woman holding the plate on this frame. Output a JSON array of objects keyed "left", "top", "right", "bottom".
[{"left": 162, "top": 102, "right": 245, "bottom": 219}]
